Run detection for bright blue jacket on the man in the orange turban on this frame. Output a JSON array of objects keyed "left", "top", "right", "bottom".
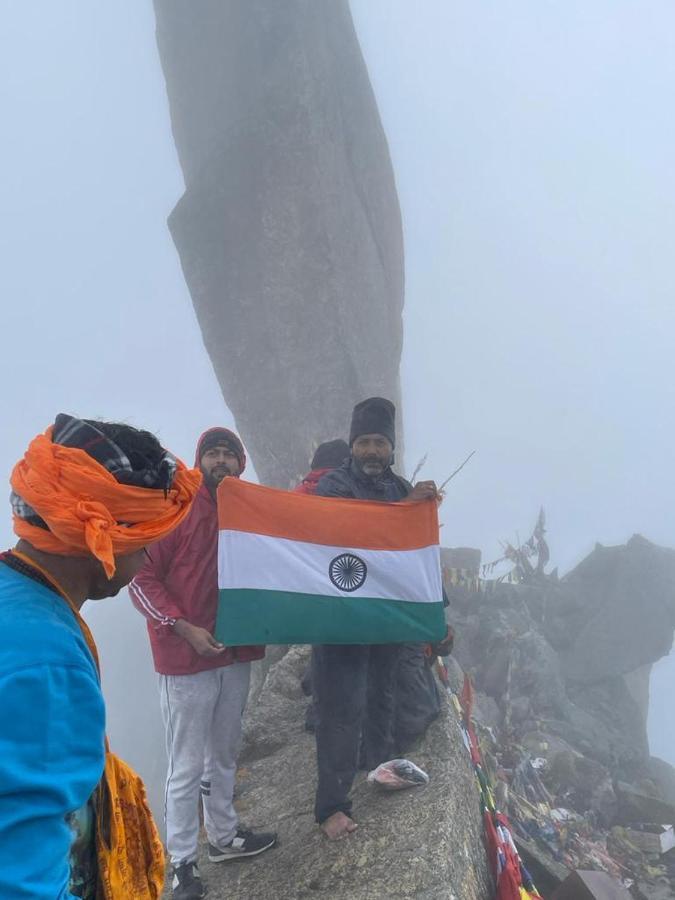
[{"left": 0, "top": 563, "right": 105, "bottom": 900}]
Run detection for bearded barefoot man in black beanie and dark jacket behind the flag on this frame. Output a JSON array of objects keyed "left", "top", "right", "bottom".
[{"left": 312, "top": 397, "right": 438, "bottom": 840}]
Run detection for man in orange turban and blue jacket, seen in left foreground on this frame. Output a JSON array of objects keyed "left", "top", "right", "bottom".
[{"left": 0, "top": 414, "right": 201, "bottom": 900}]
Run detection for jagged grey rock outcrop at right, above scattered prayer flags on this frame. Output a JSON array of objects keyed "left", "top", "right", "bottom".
[{"left": 447, "top": 536, "right": 675, "bottom": 778}]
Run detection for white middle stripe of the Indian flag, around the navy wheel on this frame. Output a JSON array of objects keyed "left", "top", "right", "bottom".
[{"left": 218, "top": 531, "right": 443, "bottom": 603}]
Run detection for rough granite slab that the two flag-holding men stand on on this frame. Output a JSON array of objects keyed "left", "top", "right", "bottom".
[{"left": 169, "top": 648, "right": 492, "bottom": 900}]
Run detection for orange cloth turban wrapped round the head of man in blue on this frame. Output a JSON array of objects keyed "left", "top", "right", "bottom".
[{"left": 10, "top": 426, "right": 202, "bottom": 578}]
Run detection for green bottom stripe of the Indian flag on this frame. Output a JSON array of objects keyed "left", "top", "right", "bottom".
[{"left": 215, "top": 589, "right": 446, "bottom": 647}]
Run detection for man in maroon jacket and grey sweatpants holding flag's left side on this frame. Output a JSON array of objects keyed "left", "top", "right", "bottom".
[{"left": 129, "top": 428, "right": 276, "bottom": 900}]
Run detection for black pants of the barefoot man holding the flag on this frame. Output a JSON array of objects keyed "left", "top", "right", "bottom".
[{"left": 312, "top": 644, "right": 400, "bottom": 822}]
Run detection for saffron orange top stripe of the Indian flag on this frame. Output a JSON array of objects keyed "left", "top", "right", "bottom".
[{"left": 218, "top": 478, "right": 438, "bottom": 550}]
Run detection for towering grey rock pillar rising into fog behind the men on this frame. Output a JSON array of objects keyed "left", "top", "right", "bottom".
[{"left": 155, "top": 0, "right": 403, "bottom": 487}]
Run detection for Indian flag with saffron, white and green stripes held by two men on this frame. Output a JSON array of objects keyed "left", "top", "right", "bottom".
[{"left": 215, "top": 478, "right": 445, "bottom": 646}]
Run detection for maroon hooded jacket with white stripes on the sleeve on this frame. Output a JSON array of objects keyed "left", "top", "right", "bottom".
[{"left": 129, "top": 429, "right": 265, "bottom": 675}]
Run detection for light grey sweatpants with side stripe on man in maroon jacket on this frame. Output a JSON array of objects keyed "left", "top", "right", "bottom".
[{"left": 159, "top": 663, "right": 251, "bottom": 865}]
